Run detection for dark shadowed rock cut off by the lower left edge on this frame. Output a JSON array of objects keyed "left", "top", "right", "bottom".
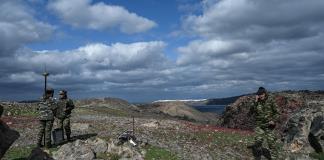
[{"left": 0, "top": 120, "right": 20, "bottom": 159}]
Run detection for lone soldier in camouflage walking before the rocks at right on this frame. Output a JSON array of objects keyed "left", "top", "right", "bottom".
[{"left": 251, "top": 87, "right": 279, "bottom": 160}]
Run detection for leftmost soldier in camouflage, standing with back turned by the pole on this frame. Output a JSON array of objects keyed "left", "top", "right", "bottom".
[{"left": 37, "top": 89, "right": 57, "bottom": 148}]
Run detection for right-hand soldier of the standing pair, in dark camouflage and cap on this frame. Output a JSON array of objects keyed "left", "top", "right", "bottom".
[{"left": 55, "top": 90, "right": 74, "bottom": 141}]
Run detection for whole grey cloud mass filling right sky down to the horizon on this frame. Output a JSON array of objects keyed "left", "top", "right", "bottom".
[{"left": 177, "top": 0, "right": 324, "bottom": 92}]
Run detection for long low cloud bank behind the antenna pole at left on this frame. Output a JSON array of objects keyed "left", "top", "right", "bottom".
[{"left": 0, "top": 41, "right": 171, "bottom": 100}]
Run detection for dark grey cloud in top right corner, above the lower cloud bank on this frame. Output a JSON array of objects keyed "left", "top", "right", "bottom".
[{"left": 183, "top": 0, "right": 324, "bottom": 41}]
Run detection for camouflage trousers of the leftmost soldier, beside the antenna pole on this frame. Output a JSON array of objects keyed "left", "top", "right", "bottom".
[{"left": 37, "top": 120, "right": 54, "bottom": 148}]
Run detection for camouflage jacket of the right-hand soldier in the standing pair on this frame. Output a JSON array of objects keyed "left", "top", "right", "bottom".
[{"left": 55, "top": 99, "right": 74, "bottom": 119}]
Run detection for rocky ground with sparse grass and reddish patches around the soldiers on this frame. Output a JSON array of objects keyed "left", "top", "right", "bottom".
[{"left": 1, "top": 91, "right": 324, "bottom": 159}]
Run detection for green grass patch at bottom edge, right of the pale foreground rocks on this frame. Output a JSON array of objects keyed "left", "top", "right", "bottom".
[{"left": 145, "top": 145, "right": 178, "bottom": 160}]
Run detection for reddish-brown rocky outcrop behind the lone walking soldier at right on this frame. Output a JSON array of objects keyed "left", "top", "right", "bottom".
[{"left": 222, "top": 91, "right": 324, "bottom": 159}]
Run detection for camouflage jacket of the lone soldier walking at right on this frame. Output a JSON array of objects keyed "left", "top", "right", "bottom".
[{"left": 252, "top": 96, "right": 279, "bottom": 128}]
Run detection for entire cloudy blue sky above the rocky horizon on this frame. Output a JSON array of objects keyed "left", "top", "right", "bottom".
[{"left": 0, "top": 0, "right": 324, "bottom": 102}]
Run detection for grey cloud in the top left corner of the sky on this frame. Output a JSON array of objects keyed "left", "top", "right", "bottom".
[{"left": 0, "top": 0, "right": 55, "bottom": 56}]
